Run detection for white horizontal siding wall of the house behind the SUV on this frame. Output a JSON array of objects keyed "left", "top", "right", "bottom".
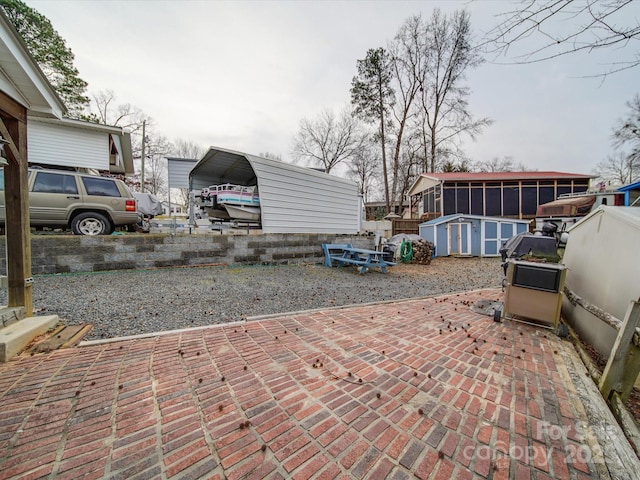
[{"left": 27, "top": 119, "right": 109, "bottom": 170}]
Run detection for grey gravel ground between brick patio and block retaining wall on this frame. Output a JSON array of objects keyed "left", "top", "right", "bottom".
[{"left": 0, "top": 258, "right": 503, "bottom": 340}]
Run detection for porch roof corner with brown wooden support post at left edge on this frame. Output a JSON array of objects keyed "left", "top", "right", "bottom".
[{"left": 0, "top": 11, "right": 65, "bottom": 316}]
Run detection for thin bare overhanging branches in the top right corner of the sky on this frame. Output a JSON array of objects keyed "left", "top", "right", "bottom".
[{"left": 483, "top": 0, "right": 640, "bottom": 76}]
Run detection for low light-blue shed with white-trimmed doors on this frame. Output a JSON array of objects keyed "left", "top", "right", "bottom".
[{"left": 419, "top": 214, "right": 530, "bottom": 257}]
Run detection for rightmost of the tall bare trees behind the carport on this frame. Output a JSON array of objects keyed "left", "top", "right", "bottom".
[{"left": 420, "top": 9, "right": 492, "bottom": 172}]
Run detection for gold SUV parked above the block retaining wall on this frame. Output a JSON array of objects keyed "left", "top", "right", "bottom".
[{"left": 0, "top": 169, "right": 139, "bottom": 235}]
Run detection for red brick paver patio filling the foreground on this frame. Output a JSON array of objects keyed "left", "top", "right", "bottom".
[{"left": 0, "top": 290, "right": 632, "bottom": 480}]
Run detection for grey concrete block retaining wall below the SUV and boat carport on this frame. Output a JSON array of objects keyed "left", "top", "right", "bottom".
[{"left": 0, "top": 233, "right": 374, "bottom": 275}]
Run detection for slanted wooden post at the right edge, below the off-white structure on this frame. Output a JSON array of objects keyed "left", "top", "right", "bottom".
[{"left": 599, "top": 301, "right": 640, "bottom": 402}]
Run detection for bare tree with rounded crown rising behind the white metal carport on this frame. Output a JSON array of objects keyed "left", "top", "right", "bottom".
[{"left": 292, "top": 108, "right": 365, "bottom": 173}]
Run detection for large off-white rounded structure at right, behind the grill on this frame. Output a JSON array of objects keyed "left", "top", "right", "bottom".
[{"left": 562, "top": 206, "right": 640, "bottom": 357}]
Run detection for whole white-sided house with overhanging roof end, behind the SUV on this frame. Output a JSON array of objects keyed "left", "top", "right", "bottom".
[{"left": 27, "top": 115, "right": 134, "bottom": 175}]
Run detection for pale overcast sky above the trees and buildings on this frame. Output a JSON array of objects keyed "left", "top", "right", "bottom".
[{"left": 26, "top": 0, "right": 640, "bottom": 173}]
